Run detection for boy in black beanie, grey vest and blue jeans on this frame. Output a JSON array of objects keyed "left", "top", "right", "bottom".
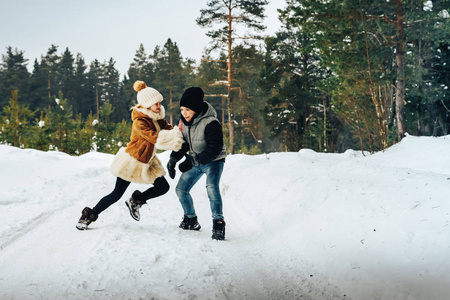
[{"left": 167, "top": 87, "right": 226, "bottom": 240}]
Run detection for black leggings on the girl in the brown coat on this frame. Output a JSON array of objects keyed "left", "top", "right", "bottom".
[{"left": 92, "top": 177, "right": 170, "bottom": 215}]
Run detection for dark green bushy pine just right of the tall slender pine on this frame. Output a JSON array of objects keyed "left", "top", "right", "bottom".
[{"left": 259, "top": 23, "right": 329, "bottom": 151}]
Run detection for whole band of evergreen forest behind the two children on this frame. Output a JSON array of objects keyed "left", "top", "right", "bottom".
[{"left": 0, "top": 0, "right": 450, "bottom": 154}]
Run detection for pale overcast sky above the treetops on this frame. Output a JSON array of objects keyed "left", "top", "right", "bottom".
[{"left": 0, "top": 0, "right": 285, "bottom": 78}]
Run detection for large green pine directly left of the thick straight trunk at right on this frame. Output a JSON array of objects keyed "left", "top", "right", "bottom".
[{"left": 282, "top": 0, "right": 396, "bottom": 151}]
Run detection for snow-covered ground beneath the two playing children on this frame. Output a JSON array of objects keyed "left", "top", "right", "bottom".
[{"left": 0, "top": 136, "right": 450, "bottom": 300}]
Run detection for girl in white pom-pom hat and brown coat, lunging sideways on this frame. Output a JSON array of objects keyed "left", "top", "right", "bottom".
[{"left": 76, "top": 81, "right": 183, "bottom": 230}]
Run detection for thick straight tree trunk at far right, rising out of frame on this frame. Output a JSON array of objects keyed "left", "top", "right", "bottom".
[{"left": 395, "top": 0, "right": 406, "bottom": 141}]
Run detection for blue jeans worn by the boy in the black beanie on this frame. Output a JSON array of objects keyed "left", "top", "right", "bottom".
[{"left": 176, "top": 161, "right": 224, "bottom": 220}]
